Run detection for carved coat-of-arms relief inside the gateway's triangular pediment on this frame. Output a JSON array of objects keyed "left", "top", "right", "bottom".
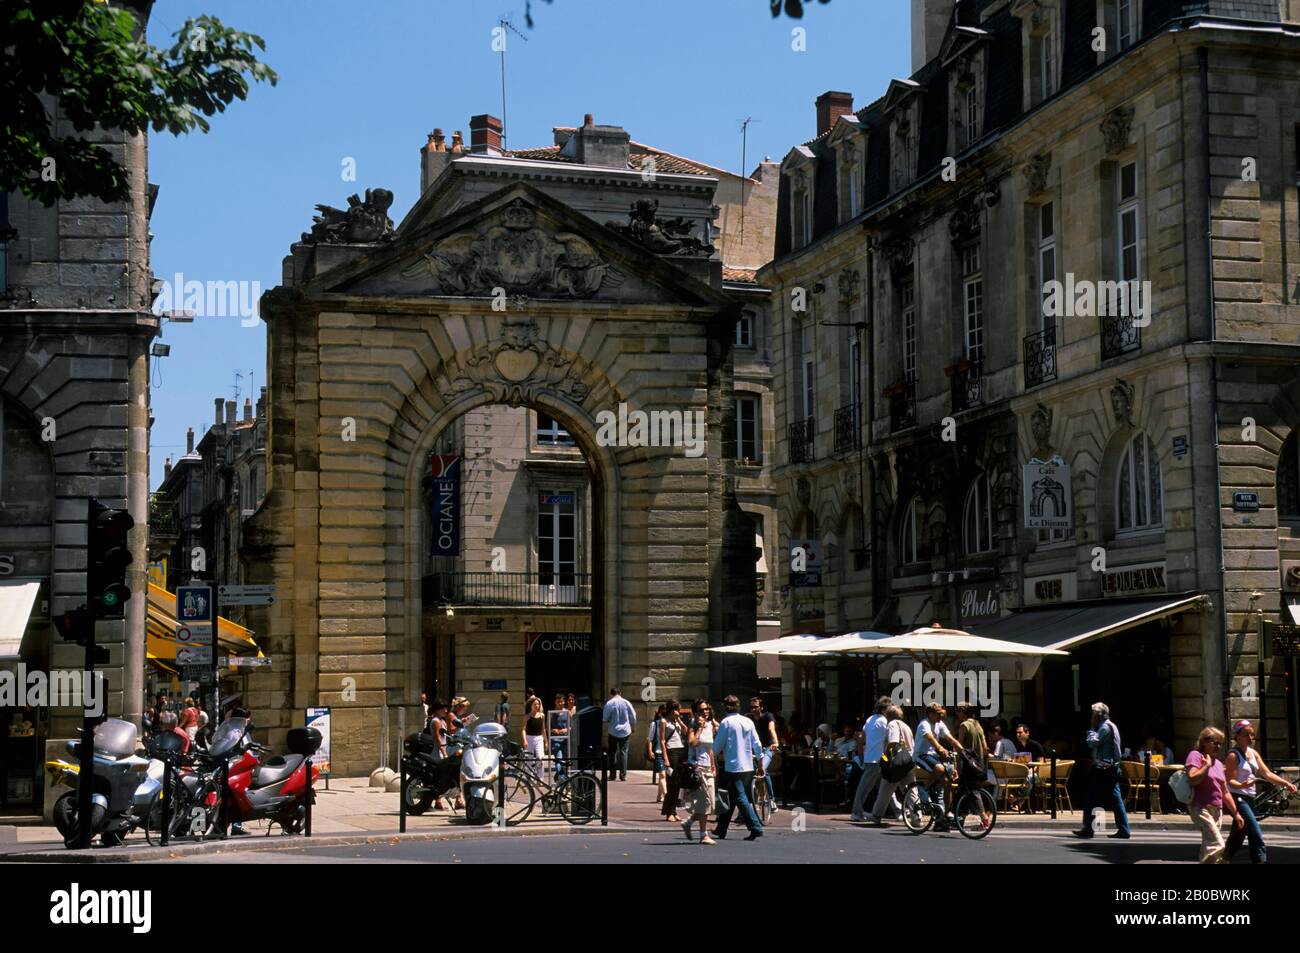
[{"left": 402, "top": 199, "right": 627, "bottom": 298}]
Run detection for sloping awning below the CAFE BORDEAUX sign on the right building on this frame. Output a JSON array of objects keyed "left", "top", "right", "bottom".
[{"left": 970, "top": 595, "right": 1204, "bottom": 650}]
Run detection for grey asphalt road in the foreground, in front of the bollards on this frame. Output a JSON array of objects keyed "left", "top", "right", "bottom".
[{"left": 152, "top": 828, "right": 1300, "bottom": 865}]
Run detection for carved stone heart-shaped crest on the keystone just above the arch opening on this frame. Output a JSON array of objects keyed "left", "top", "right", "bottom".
[{"left": 439, "top": 319, "right": 592, "bottom": 407}]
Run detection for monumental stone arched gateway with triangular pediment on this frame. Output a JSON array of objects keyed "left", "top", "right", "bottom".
[{"left": 244, "top": 163, "right": 755, "bottom": 775}]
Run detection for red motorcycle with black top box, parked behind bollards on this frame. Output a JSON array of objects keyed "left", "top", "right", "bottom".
[{"left": 204, "top": 718, "right": 321, "bottom": 835}]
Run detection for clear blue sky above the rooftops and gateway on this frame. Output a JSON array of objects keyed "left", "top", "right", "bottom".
[{"left": 150, "top": 0, "right": 910, "bottom": 488}]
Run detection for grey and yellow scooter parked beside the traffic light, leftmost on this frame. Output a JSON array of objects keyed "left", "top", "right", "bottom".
[{"left": 46, "top": 718, "right": 150, "bottom": 849}]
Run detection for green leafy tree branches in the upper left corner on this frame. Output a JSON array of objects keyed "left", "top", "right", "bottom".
[{"left": 0, "top": 0, "right": 278, "bottom": 205}]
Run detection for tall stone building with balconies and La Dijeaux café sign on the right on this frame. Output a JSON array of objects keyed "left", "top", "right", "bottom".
[{"left": 761, "top": 0, "right": 1300, "bottom": 757}]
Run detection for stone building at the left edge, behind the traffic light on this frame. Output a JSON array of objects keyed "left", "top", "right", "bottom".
[{"left": 0, "top": 4, "right": 159, "bottom": 801}]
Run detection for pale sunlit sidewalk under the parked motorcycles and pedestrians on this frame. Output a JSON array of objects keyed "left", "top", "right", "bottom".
[{"left": 0, "top": 771, "right": 1300, "bottom": 863}]
